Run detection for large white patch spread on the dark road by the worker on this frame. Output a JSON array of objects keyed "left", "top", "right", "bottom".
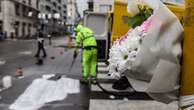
[{"left": 9, "top": 78, "right": 80, "bottom": 110}]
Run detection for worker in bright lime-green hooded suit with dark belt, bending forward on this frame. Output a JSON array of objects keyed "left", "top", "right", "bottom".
[{"left": 74, "top": 25, "right": 98, "bottom": 83}]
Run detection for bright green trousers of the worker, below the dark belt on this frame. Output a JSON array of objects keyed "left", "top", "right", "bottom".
[{"left": 82, "top": 47, "right": 98, "bottom": 80}]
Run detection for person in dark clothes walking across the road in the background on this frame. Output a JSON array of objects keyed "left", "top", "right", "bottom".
[{"left": 35, "top": 30, "right": 47, "bottom": 58}]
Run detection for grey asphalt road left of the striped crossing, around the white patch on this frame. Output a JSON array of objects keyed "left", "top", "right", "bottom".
[{"left": 0, "top": 37, "right": 90, "bottom": 110}]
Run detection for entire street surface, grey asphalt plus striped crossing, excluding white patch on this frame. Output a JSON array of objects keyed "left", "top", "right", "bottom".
[{"left": 0, "top": 37, "right": 178, "bottom": 110}]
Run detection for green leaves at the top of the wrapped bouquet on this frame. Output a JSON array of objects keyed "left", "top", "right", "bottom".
[{"left": 128, "top": 4, "right": 153, "bottom": 28}]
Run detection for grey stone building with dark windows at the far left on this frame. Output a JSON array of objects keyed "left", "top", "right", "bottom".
[{"left": 0, "top": 0, "right": 39, "bottom": 38}]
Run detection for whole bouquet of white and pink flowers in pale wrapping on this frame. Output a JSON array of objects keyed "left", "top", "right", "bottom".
[{"left": 108, "top": 0, "right": 183, "bottom": 103}]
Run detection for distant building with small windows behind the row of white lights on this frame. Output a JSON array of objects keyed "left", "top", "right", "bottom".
[{"left": 39, "top": 0, "right": 67, "bottom": 34}]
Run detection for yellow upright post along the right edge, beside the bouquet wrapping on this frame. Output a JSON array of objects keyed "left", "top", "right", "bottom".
[{"left": 181, "top": 0, "right": 194, "bottom": 96}]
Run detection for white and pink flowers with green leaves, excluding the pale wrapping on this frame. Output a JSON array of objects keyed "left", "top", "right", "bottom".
[{"left": 108, "top": 4, "right": 153, "bottom": 78}]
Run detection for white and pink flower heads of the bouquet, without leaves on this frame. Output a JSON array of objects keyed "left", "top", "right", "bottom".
[{"left": 108, "top": 5, "right": 153, "bottom": 78}]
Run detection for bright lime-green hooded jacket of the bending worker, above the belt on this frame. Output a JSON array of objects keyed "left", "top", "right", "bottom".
[{"left": 74, "top": 25, "right": 97, "bottom": 47}]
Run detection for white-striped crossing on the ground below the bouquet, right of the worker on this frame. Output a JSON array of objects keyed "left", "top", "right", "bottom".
[{"left": 89, "top": 63, "right": 178, "bottom": 110}]
